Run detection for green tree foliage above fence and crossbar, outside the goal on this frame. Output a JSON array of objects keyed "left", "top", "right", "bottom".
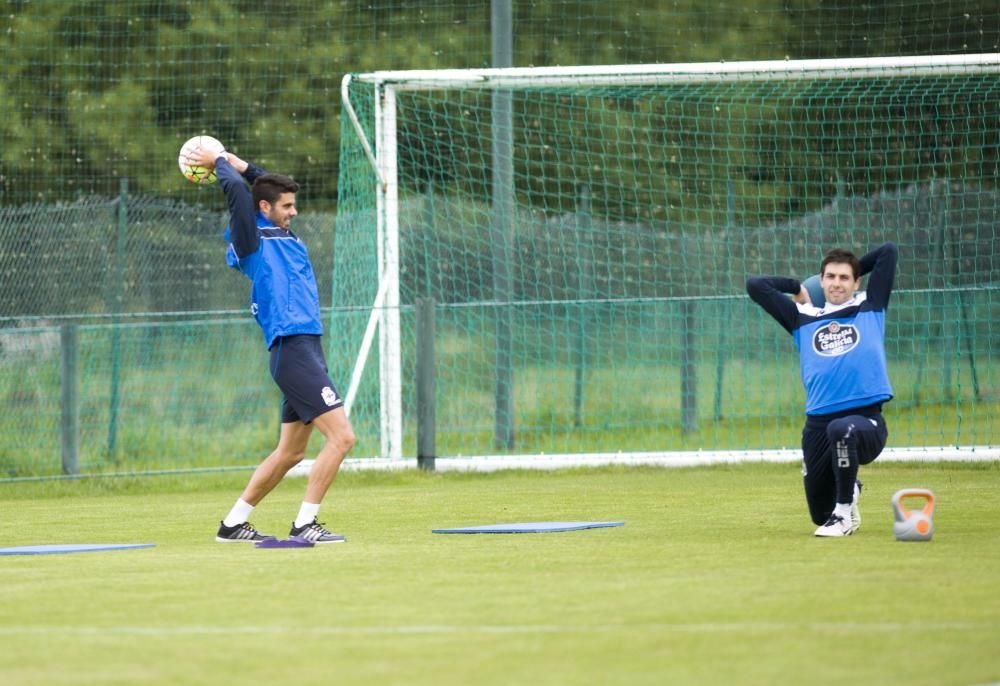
[{"left": 0, "top": 0, "right": 1000, "bottom": 208}]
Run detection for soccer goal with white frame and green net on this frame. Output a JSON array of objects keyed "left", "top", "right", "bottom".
[{"left": 330, "top": 54, "right": 1000, "bottom": 465}]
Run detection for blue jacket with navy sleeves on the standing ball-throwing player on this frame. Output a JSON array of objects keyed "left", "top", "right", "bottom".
[{"left": 215, "top": 157, "right": 323, "bottom": 349}]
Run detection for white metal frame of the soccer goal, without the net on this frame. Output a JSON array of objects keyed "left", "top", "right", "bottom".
[{"left": 341, "top": 53, "right": 1000, "bottom": 472}]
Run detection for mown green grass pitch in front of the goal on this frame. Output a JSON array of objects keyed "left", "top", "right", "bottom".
[{"left": 0, "top": 462, "right": 1000, "bottom": 686}]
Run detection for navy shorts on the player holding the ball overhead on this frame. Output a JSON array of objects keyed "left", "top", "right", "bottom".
[{"left": 271, "top": 335, "right": 344, "bottom": 424}]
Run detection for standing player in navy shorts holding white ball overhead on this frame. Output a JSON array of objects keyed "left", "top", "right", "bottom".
[{"left": 191, "top": 149, "right": 355, "bottom": 543}]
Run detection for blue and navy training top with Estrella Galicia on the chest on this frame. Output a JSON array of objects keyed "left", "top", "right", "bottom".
[{"left": 747, "top": 243, "right": 898, "bottom": 416}]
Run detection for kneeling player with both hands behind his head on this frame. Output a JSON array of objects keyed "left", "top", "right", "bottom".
[{"left": 747, "top": 243, "right": 898, "bottom": 537}]
